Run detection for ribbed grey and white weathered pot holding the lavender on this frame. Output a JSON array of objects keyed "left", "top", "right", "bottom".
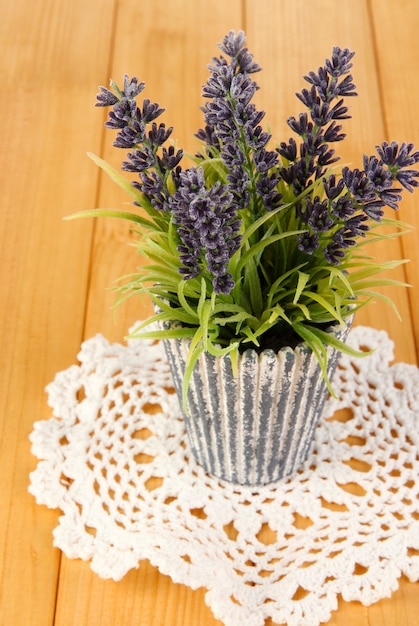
[{"left": 163, "top": 326, "right": 349, "bottom": 485}]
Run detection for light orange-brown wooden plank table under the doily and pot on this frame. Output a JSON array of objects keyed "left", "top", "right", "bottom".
[{"left": 0, "top": 0, "right": 419, "bottom": 626}]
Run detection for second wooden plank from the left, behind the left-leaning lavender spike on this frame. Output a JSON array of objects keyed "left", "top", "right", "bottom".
[{"left": 55, "top": 0, "right": 242, "bottom": 626}]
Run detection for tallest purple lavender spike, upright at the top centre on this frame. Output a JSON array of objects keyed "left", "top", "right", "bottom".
[{"left": 197, "top": 31, "right": 281, "bottom": 216}]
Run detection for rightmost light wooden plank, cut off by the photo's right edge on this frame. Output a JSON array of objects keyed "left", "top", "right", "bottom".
[{"left": 370, "top": 0, "right": 419, "bottom": 361}]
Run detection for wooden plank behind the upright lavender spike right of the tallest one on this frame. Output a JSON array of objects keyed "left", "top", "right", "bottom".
[{"left": 246, "top": 0, "right": 417, "bottom": 363}]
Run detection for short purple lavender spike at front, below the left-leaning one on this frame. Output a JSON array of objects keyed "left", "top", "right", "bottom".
[{"left": 169, "top": 167, "right": 241, "bottom": 294}]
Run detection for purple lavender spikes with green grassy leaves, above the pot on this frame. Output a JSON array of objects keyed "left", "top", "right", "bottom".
[{"left": 69, "top": 31, "right": 419, "bottom": 394}]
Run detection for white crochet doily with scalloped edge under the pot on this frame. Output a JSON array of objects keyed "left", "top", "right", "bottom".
[{"left": 30, "top": 327, "right": 419, "bottom": 626}]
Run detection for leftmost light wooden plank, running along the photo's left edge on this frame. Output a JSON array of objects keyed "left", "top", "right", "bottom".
[{"left": 0, "top": 0, "right": 113, "bottom": 626}]
